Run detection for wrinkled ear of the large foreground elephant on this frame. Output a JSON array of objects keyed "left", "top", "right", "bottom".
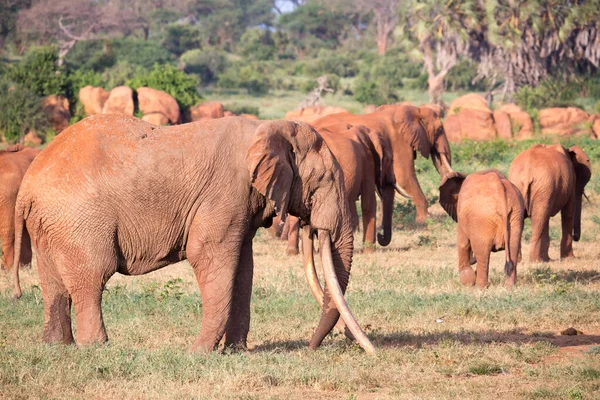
[{"left": 246, "top": 121, "right": 298, "bottom": 221}]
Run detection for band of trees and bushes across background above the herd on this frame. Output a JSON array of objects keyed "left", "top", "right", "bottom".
[{"left": 0, "top": 0, "right": 600, "bottom": 139}]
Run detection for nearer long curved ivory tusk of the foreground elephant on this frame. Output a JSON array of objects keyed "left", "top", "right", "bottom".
[{"left": 319, "top": 230, "right": 375, "bottom": 354}]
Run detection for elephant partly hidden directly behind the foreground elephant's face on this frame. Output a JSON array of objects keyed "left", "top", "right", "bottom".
[{"left": 284, "top": 122, "right": 410, "bottom": 255}]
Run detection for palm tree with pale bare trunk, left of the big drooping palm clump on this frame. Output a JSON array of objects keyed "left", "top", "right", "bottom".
[{"left": 401, "top": 0, "right": 480, "bottom": 104}]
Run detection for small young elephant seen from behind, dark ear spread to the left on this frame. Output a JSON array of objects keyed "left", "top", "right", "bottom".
[{"left": 440, "top": 169, "right": 524, "bottom": 289}]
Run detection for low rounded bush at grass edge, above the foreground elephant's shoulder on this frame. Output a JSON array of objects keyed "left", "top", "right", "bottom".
[{"left": 218, "top": 64, "right": 271, "bottom": 96}]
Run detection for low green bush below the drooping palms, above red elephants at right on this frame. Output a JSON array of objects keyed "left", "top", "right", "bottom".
[{"left": 514, "top": 78, "right": 579, "bottom": 112}]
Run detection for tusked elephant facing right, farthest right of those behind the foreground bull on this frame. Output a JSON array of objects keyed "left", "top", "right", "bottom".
[{"left": 314, "top": 105, "right": 452, "bottom": 223}]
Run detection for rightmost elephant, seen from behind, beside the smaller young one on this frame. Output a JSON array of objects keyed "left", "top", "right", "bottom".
[{"left": 508, "top": 144, "right": 592, "bottom": 262}]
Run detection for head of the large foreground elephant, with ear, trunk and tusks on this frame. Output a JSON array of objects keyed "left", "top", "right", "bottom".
[{"left": 246, "top": 121, "right": 374, "bottom": 352}]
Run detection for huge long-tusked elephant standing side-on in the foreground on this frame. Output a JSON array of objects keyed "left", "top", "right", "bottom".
[{"left": 15, "top": 115, "right": 374, "bottom": 351}]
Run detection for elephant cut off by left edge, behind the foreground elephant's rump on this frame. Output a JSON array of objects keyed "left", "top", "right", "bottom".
[{"left": 0, "top": 144, "right": 40, "bottom": 269}]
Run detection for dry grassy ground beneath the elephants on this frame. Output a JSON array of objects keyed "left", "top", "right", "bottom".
[{"left": 0, "top": 138, "right": 600, "bottom": 399}]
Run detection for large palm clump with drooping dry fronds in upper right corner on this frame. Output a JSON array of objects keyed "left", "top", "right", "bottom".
[{"left": 473, "top": 0, "right": 600, "bottom": 99}]
